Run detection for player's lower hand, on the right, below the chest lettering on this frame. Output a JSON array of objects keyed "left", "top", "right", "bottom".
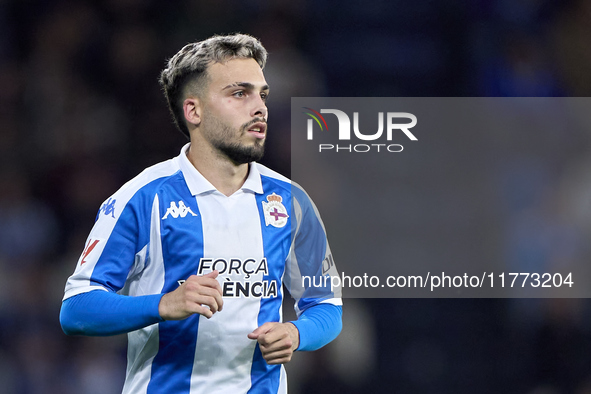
[{"left": 248, "top": 323, "right": 300, "bottom": 364}]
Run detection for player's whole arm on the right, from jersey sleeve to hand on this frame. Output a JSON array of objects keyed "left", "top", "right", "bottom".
[{"left": 248, "top": 184, "right": 342, "bottom": 364}]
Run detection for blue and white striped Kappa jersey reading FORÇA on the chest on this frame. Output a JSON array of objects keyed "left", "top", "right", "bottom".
[{"left": 64, "top": 144, "right": 341, "bottom": 394}]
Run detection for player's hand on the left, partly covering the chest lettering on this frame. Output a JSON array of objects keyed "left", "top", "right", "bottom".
[{"left": 158, "top": 271, "right": 224, "bottom": 320}]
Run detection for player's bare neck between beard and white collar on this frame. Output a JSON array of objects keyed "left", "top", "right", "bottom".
[{"left": 187, "top": 143, "right": 248, "bottom": 196}]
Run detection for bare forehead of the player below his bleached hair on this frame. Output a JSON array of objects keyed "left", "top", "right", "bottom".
[{"left": 207, "top": 58, "right": 267, "bottom": 88}]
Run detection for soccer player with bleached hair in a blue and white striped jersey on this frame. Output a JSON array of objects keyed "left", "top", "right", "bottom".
[{"left": 60, "top": 34, "right": 342, "bottom": 394}]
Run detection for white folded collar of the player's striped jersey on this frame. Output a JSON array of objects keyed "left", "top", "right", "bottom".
[{"left": 177, "top": 143, "right": 263, "bottom": 196}]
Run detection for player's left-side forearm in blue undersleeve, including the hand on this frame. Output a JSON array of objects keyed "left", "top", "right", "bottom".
[{"left": 60, "top": 271, "right": 223, "bottom": 336}]
